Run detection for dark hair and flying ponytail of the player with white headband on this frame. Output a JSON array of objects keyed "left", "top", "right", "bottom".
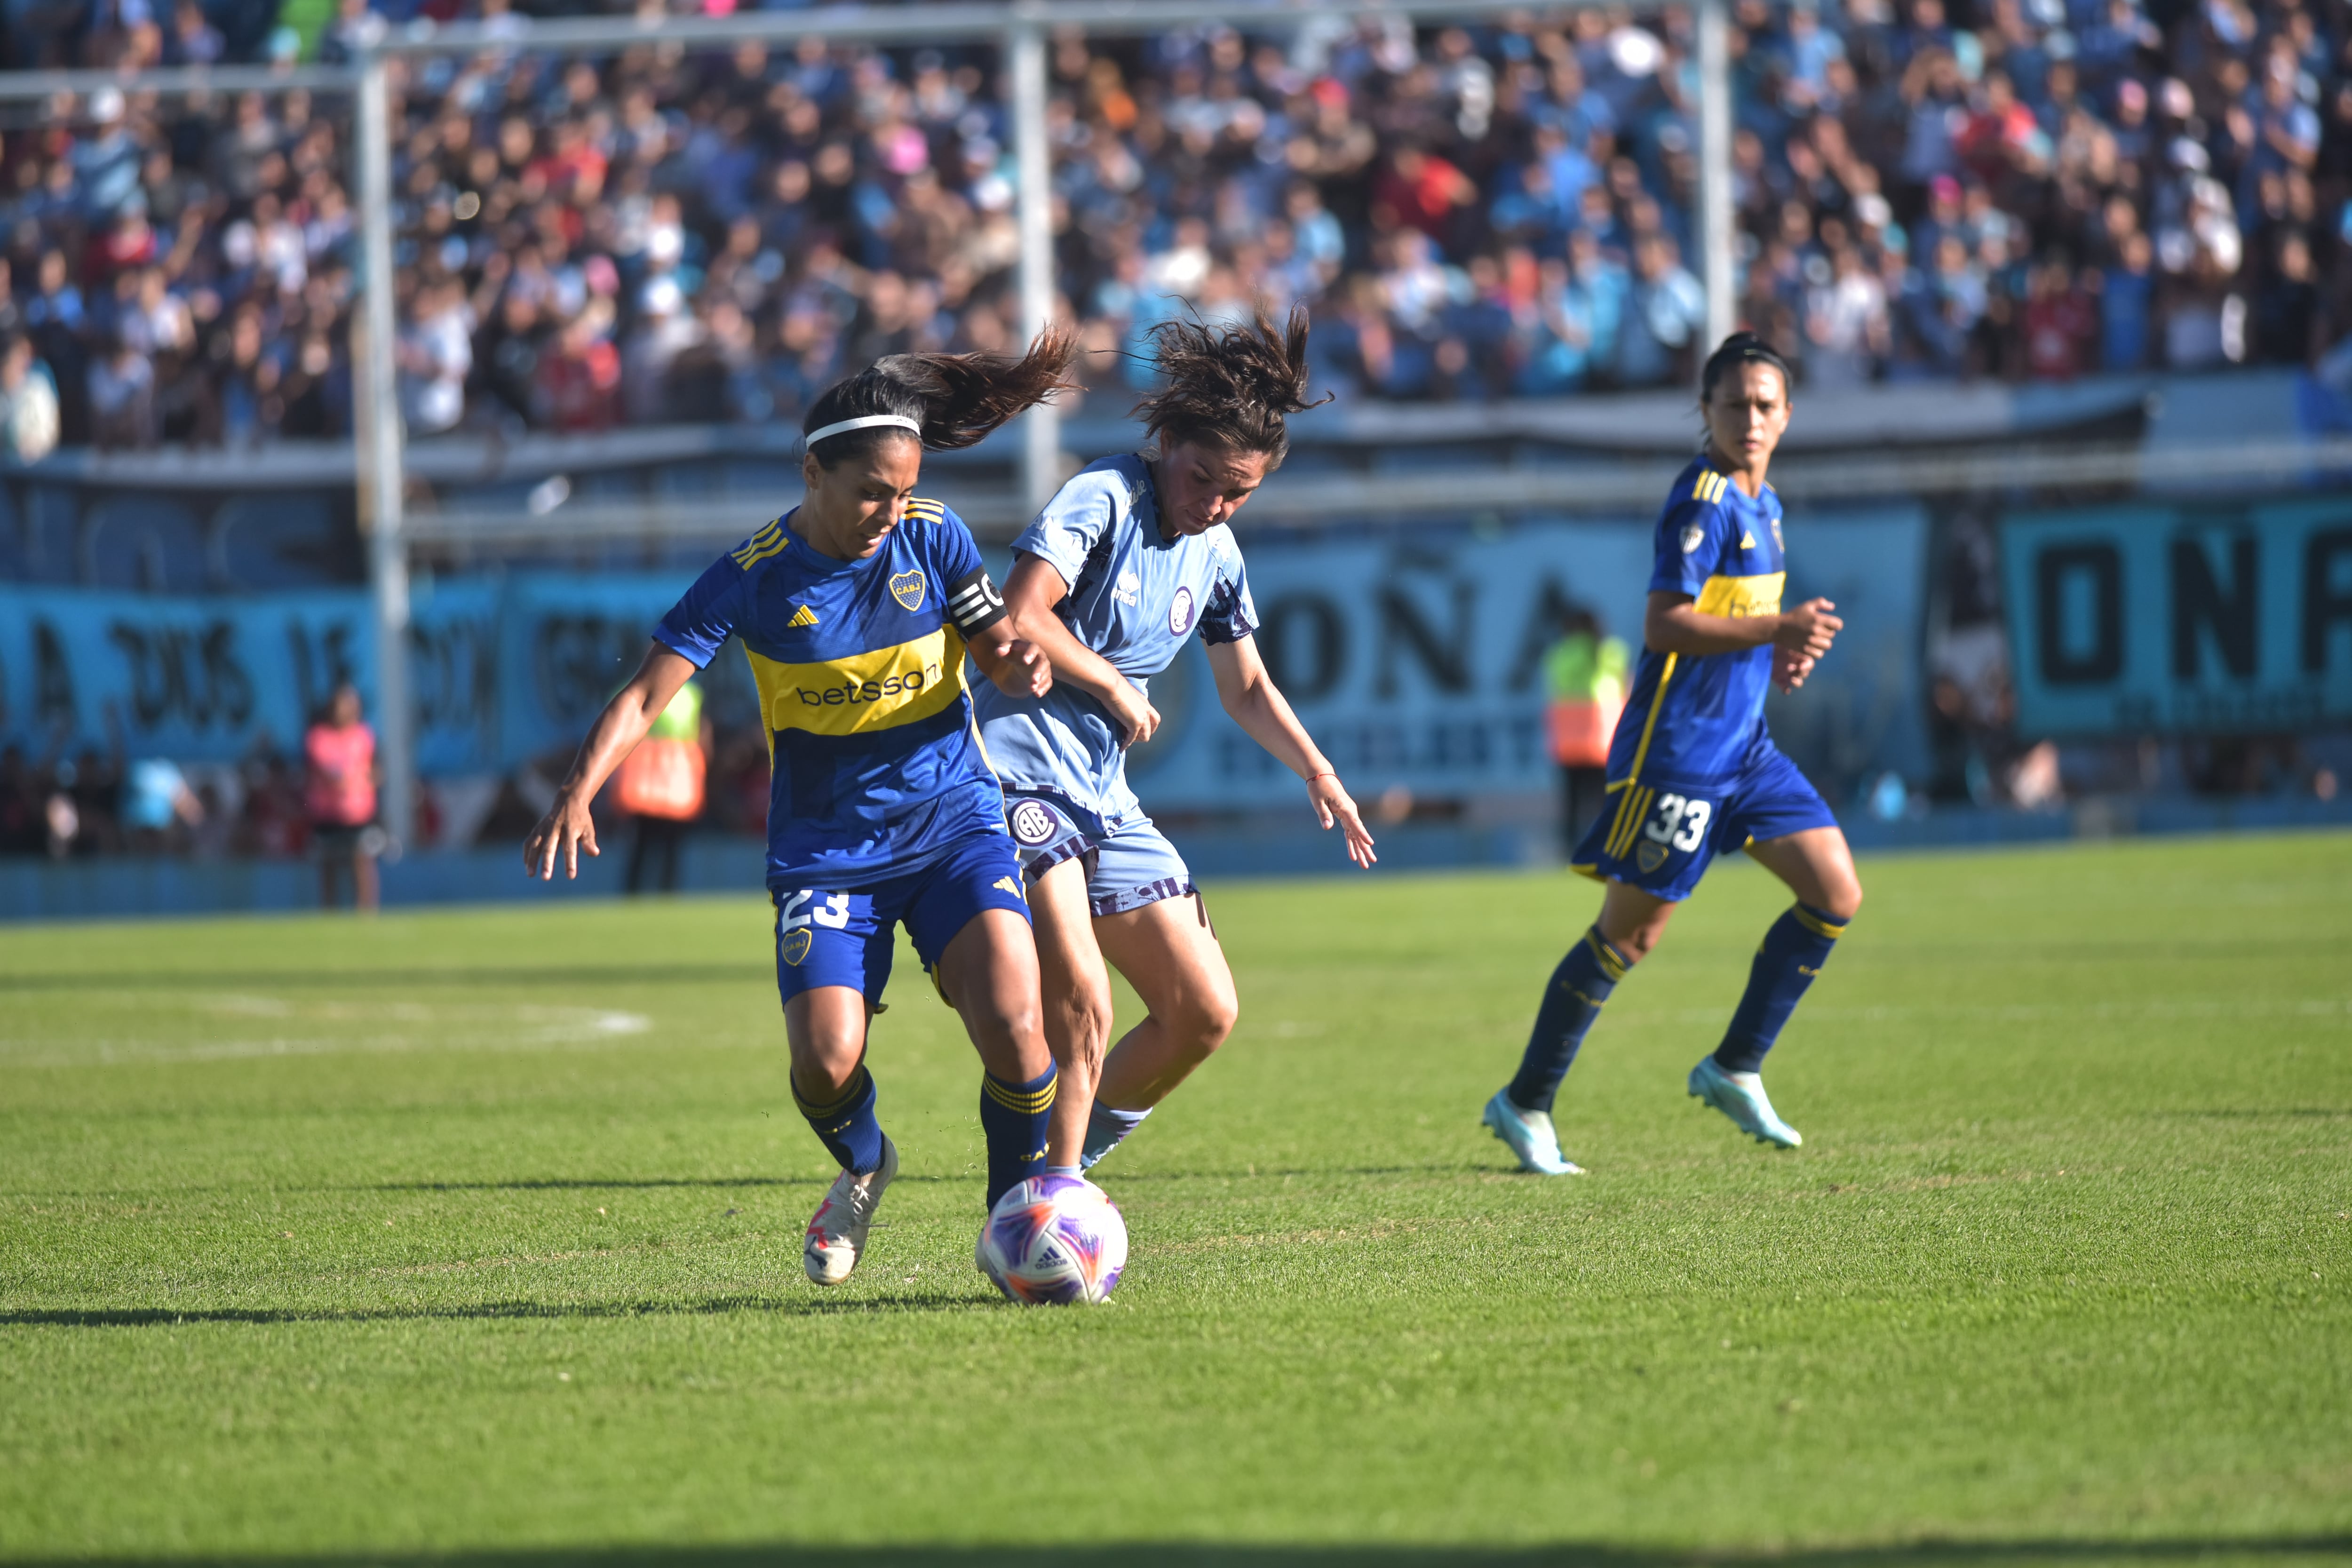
[{"left": 800, "top": 325, "right": 1077, "bottom": 468}]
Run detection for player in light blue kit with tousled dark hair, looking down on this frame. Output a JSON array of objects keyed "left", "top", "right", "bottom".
[{"left": 978, "top": 313, "right": 1374, "bottom": 1171}]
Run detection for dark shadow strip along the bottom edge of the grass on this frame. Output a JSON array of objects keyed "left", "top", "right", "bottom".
[{"left": 14, "top": 1535, "right": 2352, "bottom": 1568}]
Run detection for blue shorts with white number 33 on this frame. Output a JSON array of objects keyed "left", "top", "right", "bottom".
[{"left": 1571, "top": 740, "right": 1837, "bottom": 903}]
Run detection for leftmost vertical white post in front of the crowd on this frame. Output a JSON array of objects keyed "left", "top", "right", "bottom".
[{"left": 353, "top": 52, "right": 416, "bottom": 846}]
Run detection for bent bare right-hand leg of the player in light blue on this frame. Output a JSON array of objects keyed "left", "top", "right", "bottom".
[{"left": 1094, "top": 893, "right": 1240, "bottom": 1142}]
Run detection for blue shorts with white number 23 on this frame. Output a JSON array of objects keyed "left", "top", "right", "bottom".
[{"left": 769, "top": 832, "right": 1028, "bottom": 1006}]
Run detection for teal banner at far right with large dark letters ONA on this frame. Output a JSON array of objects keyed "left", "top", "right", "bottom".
[{"left": 2002, "top": 501, "right": 2352, "bottom": 736}]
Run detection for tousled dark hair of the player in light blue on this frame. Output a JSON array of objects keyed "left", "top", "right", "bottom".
[{"left": 1136, "top": 306, "right": 1331, "bottom": 463}]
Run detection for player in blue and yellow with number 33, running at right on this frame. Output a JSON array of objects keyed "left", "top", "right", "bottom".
[{"left": 1484, "top": 332, "right": 1863, "bottom": 1176}]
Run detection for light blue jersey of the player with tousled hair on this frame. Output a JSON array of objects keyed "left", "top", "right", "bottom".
[{"left": 971, "top": 454, "right": 1258, "bottom": 835}]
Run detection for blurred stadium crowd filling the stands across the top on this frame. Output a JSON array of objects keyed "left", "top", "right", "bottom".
[{"left": 0, "top": 0, "right": 2352, "bottom": 456}]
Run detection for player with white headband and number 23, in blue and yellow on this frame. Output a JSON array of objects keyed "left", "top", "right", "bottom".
[{"left": 522, "top": 334, "right": 1075, "bottom": 1286}]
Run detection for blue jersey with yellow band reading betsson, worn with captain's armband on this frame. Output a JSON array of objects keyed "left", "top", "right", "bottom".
[{"left": 654, "top": 498, "right": 1004, "bottom": 886}]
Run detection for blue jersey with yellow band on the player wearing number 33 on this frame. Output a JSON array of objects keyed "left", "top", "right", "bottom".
[{"left": 1609, "top": 458, "right": 1785, "bottom": 790}]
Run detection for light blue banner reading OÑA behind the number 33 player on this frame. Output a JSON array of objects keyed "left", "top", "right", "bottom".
[{"left": 1129, "top": 508, "right": 1926, "bottom": 811}]
